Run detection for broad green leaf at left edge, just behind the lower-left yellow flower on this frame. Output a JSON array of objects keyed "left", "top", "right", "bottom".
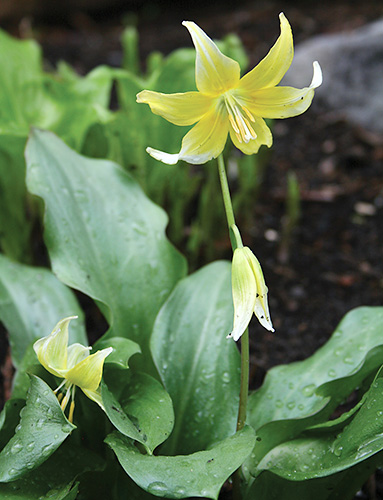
[{"left": 0, "top": 255, "right": 87, "bottom": 368}]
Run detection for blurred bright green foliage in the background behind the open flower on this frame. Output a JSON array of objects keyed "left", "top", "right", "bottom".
[{"left": 0, "top": 21, "right": 272, "bottom": 268}]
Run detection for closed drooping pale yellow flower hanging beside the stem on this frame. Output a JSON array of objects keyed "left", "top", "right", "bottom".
[{"left": 228, "top": 247, "right": 274, "bottom": 340}]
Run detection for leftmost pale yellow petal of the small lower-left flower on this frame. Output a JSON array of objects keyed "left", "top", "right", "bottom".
[{"left": 33, "top": 316, "right": 77, "bottom": 377}]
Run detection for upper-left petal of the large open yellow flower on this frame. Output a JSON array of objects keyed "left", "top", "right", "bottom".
[{"left": 182, "top": 21, "right": 240, "bottom": 96}]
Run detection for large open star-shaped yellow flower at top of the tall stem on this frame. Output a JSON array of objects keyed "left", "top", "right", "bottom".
[{"left": 137, "top": 13, "right": 322, "bottom": 165}]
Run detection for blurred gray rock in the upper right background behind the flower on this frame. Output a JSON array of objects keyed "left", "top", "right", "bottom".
[{"left": 282, "top": 19, "right": 383, "bottom": 134}]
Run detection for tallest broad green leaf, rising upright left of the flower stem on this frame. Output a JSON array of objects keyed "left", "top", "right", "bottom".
[{"left": 26, "top": 130, "right": 186, "bottom": 372}]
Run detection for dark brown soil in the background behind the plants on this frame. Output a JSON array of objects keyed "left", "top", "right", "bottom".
[{"left": 1, "top": 0, "right": 383, "bottom": 499}]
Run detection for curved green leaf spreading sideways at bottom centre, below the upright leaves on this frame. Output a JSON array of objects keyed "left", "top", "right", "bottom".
[{"left": 105, "top": 427, "right": 255, "bottom": 499}]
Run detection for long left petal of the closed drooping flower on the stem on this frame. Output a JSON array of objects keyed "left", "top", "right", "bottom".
[{"left": 228, "top": 248, "right": 257, "bottom": 341}]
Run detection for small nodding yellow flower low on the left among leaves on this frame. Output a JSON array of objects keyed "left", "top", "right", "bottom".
[{"left": 33, "top": 316, "right": 113, "bottom": 421}]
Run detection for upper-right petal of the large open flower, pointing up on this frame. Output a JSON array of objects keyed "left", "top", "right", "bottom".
[{"left": 238, "top": 12, "right": 294, "bottom": 92}]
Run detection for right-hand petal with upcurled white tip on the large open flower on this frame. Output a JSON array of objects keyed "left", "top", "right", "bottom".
[{"left": 244, "top": 61, "right": 322, "bottom": 118}]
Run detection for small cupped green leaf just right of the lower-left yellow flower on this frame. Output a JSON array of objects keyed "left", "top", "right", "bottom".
[{"left": 101, "top": 372, "right": 174, "bottom": 454}]
